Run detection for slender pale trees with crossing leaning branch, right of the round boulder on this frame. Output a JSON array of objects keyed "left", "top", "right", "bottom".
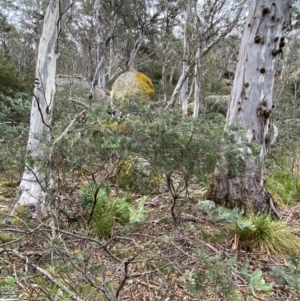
[{"left": 166, "top": 0, "right": 244, "bottom": 112}]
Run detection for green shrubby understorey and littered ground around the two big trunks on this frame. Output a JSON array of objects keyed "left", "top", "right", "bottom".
[{"left": 0, "top": 95, "right": 300, "bottom": 300}]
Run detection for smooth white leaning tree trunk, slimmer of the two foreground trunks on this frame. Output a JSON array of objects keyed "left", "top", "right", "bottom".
[{"left": 14, "top": 0, "right": 69, "bottom": 210}]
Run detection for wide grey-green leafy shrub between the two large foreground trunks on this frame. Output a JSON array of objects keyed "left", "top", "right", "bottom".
[{"left": 52, "top": 99, "right": 224, "bottom": 188}]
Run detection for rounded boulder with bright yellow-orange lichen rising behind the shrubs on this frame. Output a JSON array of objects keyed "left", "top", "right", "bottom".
[{"left": 112, "top": 70, "right": 155, "bottom": 102}]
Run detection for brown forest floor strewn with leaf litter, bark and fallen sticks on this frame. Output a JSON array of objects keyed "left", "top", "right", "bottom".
[{"left": 0, "top": 179, "right": 300, "bottom": 301}]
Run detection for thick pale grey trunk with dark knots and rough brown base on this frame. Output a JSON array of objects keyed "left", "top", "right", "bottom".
[{"left": 210, "top": 0, "right": 292, "bottom": 215}]
